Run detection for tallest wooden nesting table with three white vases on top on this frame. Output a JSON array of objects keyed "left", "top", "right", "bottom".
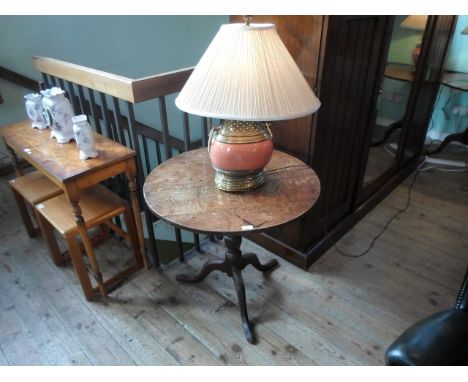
[{"left": 0, "top": 120, "right": 148, "bottom": 295}]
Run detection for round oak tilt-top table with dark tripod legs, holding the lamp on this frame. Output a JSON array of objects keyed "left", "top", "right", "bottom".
[{"left": 143, "top": 148, "right": 320, "bottom": 343}]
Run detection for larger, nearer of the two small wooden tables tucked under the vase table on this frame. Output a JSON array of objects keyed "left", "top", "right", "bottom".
[{"left": 36, "top": 185, "right": 143, "bottom": 300}]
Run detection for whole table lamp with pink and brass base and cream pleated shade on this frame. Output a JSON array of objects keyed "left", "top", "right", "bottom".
[{"left": 175, "top": 17, "right": 320, "bottom": 192}]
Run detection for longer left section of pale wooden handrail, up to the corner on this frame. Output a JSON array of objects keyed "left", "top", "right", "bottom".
[{"left": 33, "top": 57, "right": 134, "bottom": 103}]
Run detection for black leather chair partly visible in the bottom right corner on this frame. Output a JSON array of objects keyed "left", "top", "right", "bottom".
[{"left": 385, "top": 268, "right": 468, "bottom": 366}]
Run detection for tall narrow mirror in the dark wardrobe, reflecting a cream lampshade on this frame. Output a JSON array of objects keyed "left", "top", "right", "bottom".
[{"left": 363, "top": 15, "right": 427, "bottom": 187}]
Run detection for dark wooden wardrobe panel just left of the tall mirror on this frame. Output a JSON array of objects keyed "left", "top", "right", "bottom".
[{"left": 301, "top": 16, "right": 392, "bottom": 254}]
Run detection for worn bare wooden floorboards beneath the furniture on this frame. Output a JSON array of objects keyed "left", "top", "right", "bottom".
[{"left": 0, "top": 157, "right": 468, "bottom": 365}]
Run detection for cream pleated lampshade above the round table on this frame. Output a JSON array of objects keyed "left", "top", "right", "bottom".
[{"left": 175, "top": 24, "right": 320, "bottom": 121}]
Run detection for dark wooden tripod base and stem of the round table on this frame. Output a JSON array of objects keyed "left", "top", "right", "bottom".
[{"left": 176, "top": 236, "right": 278, "bottom": 344}]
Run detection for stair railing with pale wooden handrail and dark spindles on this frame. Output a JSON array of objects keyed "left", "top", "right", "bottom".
[{"left": 33, "top": 57, "right": 211, "bottom": 266}]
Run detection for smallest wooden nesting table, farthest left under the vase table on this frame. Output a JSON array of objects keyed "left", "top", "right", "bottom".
[{"left": 9, "top": 171, "right": 62, "bottom": 237}]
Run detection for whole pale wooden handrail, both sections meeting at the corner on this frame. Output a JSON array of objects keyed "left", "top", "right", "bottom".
[{"left": 33, "top": 56, "right": 193, "bottom": 103}]
